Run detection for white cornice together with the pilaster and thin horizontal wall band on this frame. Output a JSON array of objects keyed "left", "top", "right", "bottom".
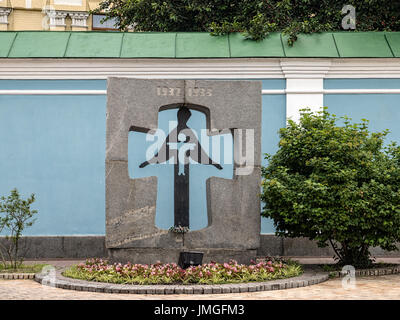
[{"left": 0, "top": 58, "right": 400, "bottom": 121}]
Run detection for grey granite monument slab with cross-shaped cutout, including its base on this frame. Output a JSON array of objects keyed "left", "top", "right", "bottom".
[{"left": 106, "top": 78, "right": 261, "bottom": 263}]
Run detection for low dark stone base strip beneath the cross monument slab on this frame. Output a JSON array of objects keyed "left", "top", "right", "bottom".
[{"left": 108, "top": 248, "right": 257, "bottom": 264}]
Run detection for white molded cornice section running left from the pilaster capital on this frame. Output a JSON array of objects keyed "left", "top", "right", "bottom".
[{"left": 0, "top": 59, "right": 284, "bottom": 79}]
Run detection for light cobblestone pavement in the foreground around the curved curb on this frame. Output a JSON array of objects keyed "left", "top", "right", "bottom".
[{"left": 0, "top": 258, "right": 400, "bottom": 300}]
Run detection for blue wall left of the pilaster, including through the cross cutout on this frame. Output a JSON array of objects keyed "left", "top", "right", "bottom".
[{"left": 0, "top": 79, "right": 286, "bottom": 235}]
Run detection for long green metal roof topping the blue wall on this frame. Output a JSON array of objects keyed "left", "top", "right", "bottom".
[{"left": 0, "top": 31, "right": 400, "bottom": 59}]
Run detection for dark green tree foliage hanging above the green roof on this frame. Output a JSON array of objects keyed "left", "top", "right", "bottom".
[{"left": 92, "top": 0, "right": 400, "bottom": 44}]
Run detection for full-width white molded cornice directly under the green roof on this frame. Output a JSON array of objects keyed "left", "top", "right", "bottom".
[{"left": 0, "top": 58, "right": 400, "bottom": 79}]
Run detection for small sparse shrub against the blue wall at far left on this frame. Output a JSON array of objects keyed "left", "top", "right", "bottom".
[{"left": 0, "top": 189, "right": 37, "bottom": 269}]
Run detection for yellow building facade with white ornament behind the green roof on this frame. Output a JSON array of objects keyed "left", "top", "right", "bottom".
[{"left": 0, "top": 0, "right": 115, "bottom": 31}]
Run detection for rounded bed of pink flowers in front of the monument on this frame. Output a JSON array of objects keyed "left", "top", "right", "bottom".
[{"left": 63, "top": 259, "right": 303, "bottom": 285}]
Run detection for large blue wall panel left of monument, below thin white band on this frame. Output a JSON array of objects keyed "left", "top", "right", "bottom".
[{"left": 0, "top": 92, "right": 106, "bottom": 235}]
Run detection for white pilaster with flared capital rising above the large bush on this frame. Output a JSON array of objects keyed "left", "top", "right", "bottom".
[{"left": 281, "top": 60, "right": 330, "bottom": 122}]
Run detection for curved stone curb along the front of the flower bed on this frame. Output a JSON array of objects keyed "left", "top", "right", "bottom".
[{"left": 34, "top": 271, "right": 329, "bottom": 295}]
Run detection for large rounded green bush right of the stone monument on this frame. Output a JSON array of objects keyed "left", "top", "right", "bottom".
[{"left": 261, "top": 109, "right": 400, "bottom": 267}]
